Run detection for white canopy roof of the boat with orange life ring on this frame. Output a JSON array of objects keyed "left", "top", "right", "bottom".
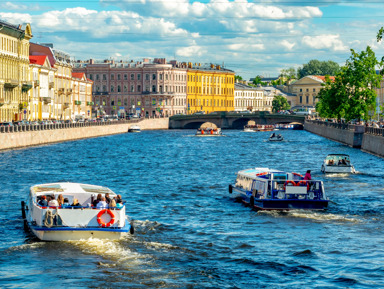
[{"left": 31, "top": 183, "right": 116, "bottom": 196}]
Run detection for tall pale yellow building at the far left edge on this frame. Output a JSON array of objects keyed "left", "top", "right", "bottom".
[{"left": 0, "top": 21, "right": 32, "bottom": 122}]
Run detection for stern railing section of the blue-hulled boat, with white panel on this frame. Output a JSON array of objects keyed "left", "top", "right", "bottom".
[{"left": 271, "top": 180, "right": 325, "bottom": 200}]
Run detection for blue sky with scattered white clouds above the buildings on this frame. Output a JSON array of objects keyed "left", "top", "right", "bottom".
[{"left": 0, "top": 0, "right": 384, "bottom": 79}]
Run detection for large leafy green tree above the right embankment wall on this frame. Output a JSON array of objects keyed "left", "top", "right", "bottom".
[{"left": 316, "top": 46, "right": 383, "bottom": 121}]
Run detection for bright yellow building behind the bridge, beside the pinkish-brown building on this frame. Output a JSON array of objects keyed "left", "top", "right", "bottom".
[{"left": 187, "top": 63, "right": 235, "bottom": 114}]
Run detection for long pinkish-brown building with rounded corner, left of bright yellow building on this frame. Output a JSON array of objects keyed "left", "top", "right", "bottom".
[{"left": 73, "top": 59, "right": 187, "bottom": 117}]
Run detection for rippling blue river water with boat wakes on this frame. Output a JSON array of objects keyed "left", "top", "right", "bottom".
[{"left": 0, "top": 130, "right": 384, "bottom": 288}]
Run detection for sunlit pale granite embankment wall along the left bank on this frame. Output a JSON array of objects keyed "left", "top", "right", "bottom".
[{"left": 0, "top": 118, "right": 169, "bottom": 150}]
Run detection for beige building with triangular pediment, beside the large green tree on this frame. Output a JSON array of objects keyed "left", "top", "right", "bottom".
[{"left": 289, "top": 75, "right": 335, "bottom": 107}]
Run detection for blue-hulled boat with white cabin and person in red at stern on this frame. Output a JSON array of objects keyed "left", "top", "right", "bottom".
[{"left": 229, "top": 168, "right": 329, "bottom": 210}]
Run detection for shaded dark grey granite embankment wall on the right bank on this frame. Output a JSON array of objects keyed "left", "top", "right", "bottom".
[{"left": 304, "top": 121, "right": 384, "bottom": 157}]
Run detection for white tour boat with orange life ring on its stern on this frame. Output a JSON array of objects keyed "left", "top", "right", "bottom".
[{"left": 22, "top": 183, "right": 134, "bottom": 241}]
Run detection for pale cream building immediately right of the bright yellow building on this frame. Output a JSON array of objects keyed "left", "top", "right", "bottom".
[{"left": 234, "top": 83, "right": 267, "bottom": 111}]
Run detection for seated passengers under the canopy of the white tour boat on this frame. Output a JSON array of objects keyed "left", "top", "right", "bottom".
[{"left": 37, "top": 193, "right": 124, "bottom": 209}]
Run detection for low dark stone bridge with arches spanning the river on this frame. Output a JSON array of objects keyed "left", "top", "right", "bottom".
[{"left": 169, "top": 111, "right": 305, "bottom": 129}]
